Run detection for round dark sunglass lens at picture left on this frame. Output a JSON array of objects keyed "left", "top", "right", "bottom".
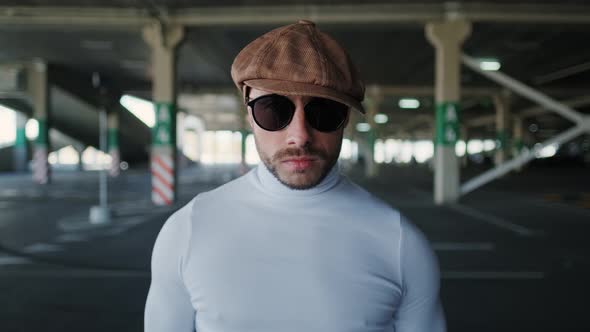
[{"left": 252, "top": 95, "right": 295, "bottom": 131}]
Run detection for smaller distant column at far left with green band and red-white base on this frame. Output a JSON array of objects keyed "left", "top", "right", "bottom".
[{"left": 27, "top": 60, "right": 51, "bottom": 184}]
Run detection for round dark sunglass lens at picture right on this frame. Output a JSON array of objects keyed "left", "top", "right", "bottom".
[{"left": 305, "top": 98, "right": 348, "bottom": 132}]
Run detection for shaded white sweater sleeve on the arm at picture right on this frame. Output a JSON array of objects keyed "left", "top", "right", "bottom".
[{"left": 394, "top": 218, "right": 446, "bottom": 332}]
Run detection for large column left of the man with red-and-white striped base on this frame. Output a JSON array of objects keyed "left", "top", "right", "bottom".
[{"left": 143, "top": 24, "right": 184, "bottom": 205}]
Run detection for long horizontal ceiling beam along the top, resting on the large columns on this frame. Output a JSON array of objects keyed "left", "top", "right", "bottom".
[{"left": 0, "top": 2, "right": 590, "bottom": 28}]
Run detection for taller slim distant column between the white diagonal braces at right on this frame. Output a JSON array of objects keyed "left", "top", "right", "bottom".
[{"left": 494, "top": 91, "right": 511, "bottom": 166}]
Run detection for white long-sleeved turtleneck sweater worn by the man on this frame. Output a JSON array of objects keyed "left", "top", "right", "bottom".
[{"left": 145, "top": 166, "right": 445, "bottom": 332}]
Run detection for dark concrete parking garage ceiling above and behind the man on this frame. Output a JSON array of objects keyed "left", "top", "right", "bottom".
[{"left": 0, "top": 0, "right": 590, "bottom": 144}]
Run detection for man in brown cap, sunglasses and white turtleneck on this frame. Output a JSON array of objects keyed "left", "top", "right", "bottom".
[{"left": 145, "top": 21, "right": 445, "bottom": 332}]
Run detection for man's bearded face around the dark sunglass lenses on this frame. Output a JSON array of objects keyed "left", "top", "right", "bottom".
[{"left": 248, "top": 88, "right": 348, "bottom": 189}]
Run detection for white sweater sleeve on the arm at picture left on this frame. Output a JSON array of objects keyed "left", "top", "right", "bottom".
[{"left": 144, "top": 204, "right": 196, "bottom": 332}]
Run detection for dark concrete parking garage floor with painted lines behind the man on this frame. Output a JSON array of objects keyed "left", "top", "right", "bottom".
[{"left": 0, "top": 165, "right": 590, "bottom": 332}]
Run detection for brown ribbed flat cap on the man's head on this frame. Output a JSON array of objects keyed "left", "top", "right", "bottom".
[{"left": 231, "top": 20, "right": 365, "bottom": 113}]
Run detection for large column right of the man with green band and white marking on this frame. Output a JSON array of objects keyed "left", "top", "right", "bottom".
[{"left": 426, "top": 20, "right": 471, "bottom": 205}]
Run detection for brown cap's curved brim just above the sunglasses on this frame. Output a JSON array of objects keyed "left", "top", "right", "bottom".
[{"left": 244, "top": 79, "right": 365, "bottom": 114}]
